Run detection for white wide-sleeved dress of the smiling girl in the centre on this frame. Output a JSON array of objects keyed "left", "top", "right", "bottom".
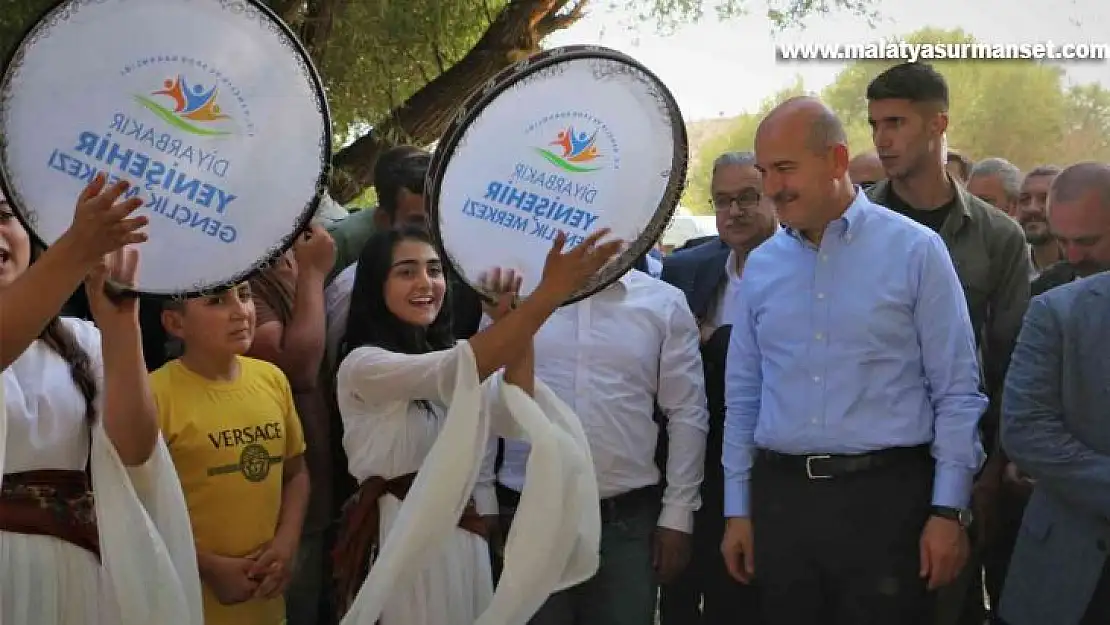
[{"left": 337, "top": 342, "right": 601, "bottom": 625}]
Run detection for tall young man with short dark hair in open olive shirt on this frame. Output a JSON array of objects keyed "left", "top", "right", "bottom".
[{"left": 867, "top": 63, "right": 1029, "bottom": 625}]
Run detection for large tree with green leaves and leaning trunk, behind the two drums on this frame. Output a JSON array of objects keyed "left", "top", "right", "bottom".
[{"left": 0, "top": 0, "right": 877, "bottom": 203}]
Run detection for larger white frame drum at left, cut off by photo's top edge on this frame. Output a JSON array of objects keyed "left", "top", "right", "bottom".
[{"left": 0, "top": 0, "right": 331, "bottom": 298}]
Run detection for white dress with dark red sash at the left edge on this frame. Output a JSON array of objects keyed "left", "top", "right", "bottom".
[{"left": 0, "top": 319, "right": 203, "bottom": 625}]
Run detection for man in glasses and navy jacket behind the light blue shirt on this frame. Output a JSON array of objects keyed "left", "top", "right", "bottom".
[{"left": 659, "top": 152, "right": 777, "bottom": 625}]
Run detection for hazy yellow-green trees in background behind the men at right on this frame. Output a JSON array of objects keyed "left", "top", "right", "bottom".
[{"left": 684, "top": 28, "right": 1110, "bottom": 212}]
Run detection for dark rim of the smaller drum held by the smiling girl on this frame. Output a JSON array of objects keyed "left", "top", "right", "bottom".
[{"left": 424, "top": 44, "right": 689, "bottom": 305}]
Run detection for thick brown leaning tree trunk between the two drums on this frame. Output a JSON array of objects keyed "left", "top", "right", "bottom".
[{"left": 330, "top": 0, "right": 588, "bottom": 204}]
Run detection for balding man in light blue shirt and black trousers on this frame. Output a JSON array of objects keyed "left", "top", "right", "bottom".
[{"left": 722, "top": 98, "right": 987, "bottom": 625}]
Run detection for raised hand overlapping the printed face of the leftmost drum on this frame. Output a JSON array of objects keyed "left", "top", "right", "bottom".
[{"left": 59, "top": 173, "right": 149, "bottom": 265}]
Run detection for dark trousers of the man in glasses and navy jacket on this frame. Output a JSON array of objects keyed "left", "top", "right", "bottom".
[{"left": 659, "top": 495, "right": 761, "bottom": 625}]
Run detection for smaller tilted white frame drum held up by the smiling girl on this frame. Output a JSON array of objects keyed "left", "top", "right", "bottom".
[{"left": 426, "top": 46, "right": 687, "bottom": 303}]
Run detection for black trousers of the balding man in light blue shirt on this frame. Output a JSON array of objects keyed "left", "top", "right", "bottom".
[{"left": 751, "top": 452, "right": 934, "bottom": 625}]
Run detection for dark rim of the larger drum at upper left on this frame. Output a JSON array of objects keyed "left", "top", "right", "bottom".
[{"left": 0, "top": 0, "right": 334, "bottom": 301}]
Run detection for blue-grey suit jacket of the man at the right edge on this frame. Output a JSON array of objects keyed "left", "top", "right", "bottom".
[{"left": 1001, "top": 273, "right": 1110, "bottom": 625}]
